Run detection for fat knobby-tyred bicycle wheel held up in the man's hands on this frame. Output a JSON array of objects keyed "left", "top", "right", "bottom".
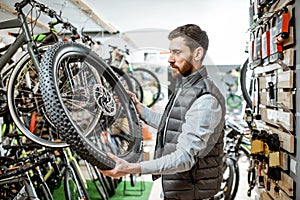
[{"left": 40, "top": 42, "right": 142, "bottom": 169}]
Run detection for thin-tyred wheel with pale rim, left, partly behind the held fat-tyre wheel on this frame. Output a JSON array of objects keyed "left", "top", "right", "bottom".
[{"left": 7, "top": 50, "right": 68, "bottom": 148}]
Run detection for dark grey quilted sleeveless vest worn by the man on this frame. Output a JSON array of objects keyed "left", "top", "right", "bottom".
[{"left": 154, "top": 66, "right": 226, "bottom": 200}]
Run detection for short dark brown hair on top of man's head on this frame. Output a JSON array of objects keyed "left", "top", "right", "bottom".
[{"left": 168, "top": 24, "right": 209, "bottom": 53}]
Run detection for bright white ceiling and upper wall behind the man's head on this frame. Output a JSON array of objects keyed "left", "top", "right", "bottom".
[{"left": 0, "top": 0, "right": 249, "bottom": 65}]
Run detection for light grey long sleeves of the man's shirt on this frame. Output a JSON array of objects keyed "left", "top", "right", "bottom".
[{"left": 140, "top": 94, "right": 222, "bottom": 174}]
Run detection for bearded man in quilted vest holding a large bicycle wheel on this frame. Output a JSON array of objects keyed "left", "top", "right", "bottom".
[{"left": 102, "top": 24, "right": 225, "bottom": 199}]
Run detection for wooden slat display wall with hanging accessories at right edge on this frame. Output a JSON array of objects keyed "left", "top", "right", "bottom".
[{"left": 249, "top": 0, "right": 300, "bottom": 200}]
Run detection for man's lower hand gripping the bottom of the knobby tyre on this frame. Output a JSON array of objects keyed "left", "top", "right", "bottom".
[{"left": 100, "top": 153, "right": 141, "bottom": 178}]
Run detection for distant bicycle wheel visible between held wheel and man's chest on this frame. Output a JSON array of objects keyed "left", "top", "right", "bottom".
[{"left": 133, "top": 68, "right": 161, "bottom": 107}]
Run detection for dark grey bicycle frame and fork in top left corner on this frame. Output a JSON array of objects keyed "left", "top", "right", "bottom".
[{"left": 0, "top": 0, "right": 40, "bottom": 71}]
